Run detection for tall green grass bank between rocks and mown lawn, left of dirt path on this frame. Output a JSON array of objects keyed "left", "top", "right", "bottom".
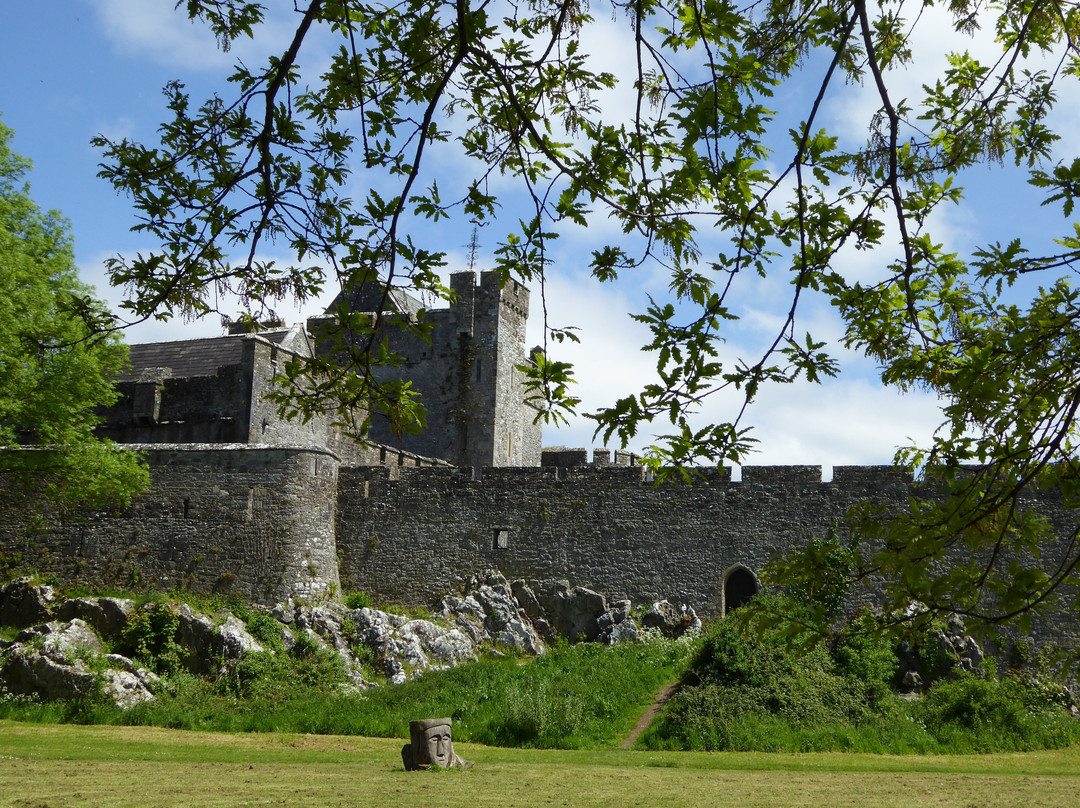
[{"left": 0, "top": 641, "right": 696, "bottom": 749}]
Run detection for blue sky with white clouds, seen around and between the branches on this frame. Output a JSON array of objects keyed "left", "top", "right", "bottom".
[{"left": 0, "top": 0, "right": 1080, "bottom": 475}]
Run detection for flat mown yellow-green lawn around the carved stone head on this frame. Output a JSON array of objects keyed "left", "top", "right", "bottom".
[{"left": 6, "top": 721, "right": 1080, "bottom": 808}]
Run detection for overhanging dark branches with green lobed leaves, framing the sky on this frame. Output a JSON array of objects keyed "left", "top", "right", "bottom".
[{"left": 96, "top": 0, "right": 1080, "bottom": 639}]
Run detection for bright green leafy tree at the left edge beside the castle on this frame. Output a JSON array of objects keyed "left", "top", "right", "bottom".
[{"left": 0, "top": 118, "right": 147, "bottom": 507}]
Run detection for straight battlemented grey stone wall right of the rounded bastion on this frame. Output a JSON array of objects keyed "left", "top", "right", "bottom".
[{"left": 337, "top": 466, "right": 910, "bottom": 615}]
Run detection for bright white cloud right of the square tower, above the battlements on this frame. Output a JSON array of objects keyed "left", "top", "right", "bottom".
[{"left": 528, "top": 259, "right": 941, "bottom": 464}]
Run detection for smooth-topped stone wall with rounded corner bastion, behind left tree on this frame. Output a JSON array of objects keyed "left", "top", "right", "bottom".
[{"left": 0, "top": 445, "right": 339, "bottom": 604}]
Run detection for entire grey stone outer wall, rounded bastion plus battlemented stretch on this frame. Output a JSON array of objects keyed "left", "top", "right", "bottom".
[{"left": 0, "top": 445, "right": 1080, "bottom": 644}]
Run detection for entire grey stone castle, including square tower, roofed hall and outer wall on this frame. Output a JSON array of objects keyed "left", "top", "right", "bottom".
[{"left": 0, "top": 272, "right": 1076, "bottom": 641}]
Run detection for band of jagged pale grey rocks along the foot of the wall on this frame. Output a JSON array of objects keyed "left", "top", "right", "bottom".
[{"left": 0, "top": 571, "right": 701, "bottom": 708}]
